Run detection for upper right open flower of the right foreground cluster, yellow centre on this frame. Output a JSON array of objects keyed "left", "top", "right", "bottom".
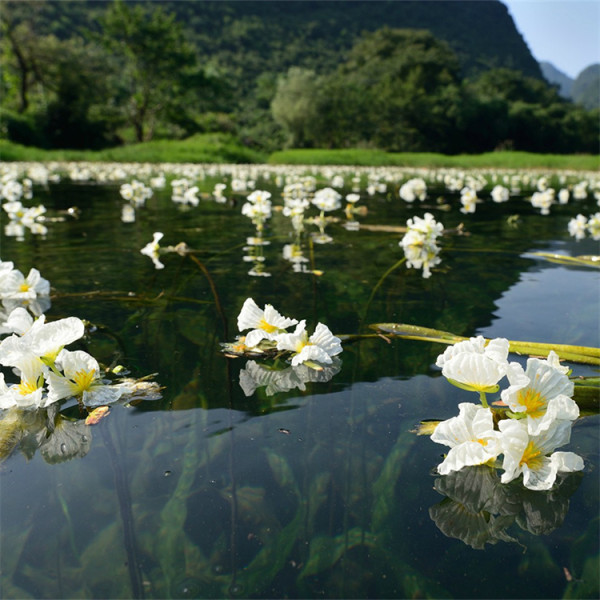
[{"left": 501, "top": 351, "right": 579, "bottom": 435}]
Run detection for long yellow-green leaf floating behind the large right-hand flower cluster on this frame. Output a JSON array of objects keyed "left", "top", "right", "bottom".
[{"left": 369, "top": 323, "right": 600, "bottom": 365}]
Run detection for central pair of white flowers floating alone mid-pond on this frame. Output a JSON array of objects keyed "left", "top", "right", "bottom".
[{"left": 233, "top": 298, "right": 342, "bottom": 367}]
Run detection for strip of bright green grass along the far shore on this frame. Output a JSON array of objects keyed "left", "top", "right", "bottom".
[{"left": 0, "top": 134, "right": 600, "bottom": 171}]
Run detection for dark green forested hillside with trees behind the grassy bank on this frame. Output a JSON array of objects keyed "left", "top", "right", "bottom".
[{"left": 0, "top": 0, "right": 597, "bottom": 153}]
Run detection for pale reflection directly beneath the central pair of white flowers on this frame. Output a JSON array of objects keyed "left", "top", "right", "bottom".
[{"left": 240, "top": 358, "right": 341, "bottom": 396}]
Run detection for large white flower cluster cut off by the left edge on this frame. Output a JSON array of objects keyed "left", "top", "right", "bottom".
[{"left": 0, "top": 261, "right": 162, "bottom": 410}]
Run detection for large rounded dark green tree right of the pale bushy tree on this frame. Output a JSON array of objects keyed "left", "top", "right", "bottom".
[{"left": 304, "top": 28, "right": 461, "bottom": 152}]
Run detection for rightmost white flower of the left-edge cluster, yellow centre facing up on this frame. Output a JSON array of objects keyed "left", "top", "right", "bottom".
[{"left": 46, "top": 350, "right": 124, "bottom": 406}]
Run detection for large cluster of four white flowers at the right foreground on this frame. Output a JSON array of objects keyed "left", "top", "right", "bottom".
[{"left": 431, "top": 336, "right": 583, "bottom": 490}]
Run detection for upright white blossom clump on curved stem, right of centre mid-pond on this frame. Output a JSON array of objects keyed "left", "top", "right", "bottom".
[{"left": 399, "top": 213, "right": 444, "bottom": 278}]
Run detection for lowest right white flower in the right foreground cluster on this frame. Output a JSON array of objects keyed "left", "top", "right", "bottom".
[{"left": 499, "top": 419, "right": 583, "bottom": 490}]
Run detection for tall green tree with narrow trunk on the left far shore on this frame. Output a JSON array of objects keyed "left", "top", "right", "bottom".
[{"left": 101, "top": 0, "right": 201, "bottom": 142}]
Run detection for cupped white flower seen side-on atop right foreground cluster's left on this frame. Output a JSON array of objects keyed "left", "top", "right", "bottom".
[{"left": 436, "top": 336, "right": 508, "bottom": 392}]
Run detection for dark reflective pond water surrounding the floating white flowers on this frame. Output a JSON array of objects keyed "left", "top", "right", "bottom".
[{"left": 0, "top": 164, "right": 600, "bottom": 598}]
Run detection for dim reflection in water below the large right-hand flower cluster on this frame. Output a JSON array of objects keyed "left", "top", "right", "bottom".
[{"left": 429, "top": 465, "right": 582, "bottom": 550}]
